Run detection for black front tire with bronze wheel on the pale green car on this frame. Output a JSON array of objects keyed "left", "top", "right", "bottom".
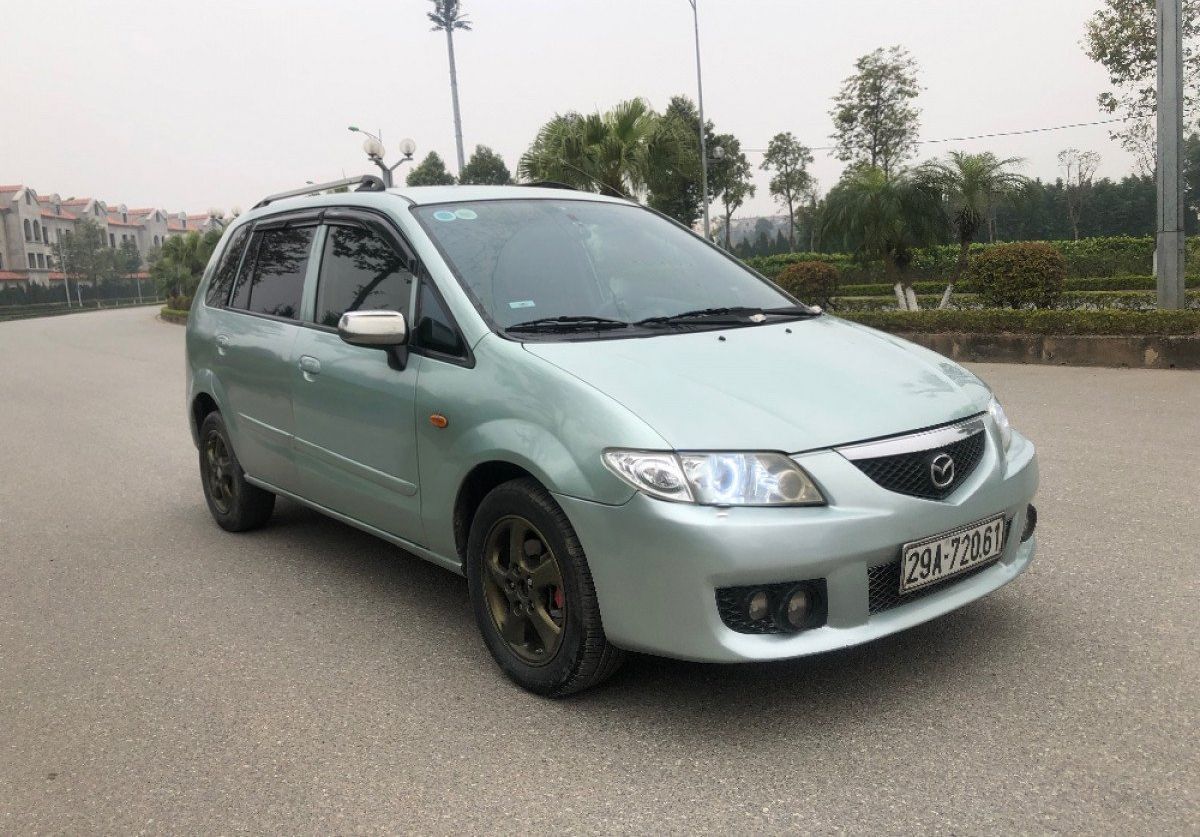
[{"left": 466, "top": 478, "right": 624, "bottom": 698}]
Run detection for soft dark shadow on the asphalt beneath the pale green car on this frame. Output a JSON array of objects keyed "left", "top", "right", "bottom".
[{"left": 250, "top": 501, "right": 1028, "bottom": 736}]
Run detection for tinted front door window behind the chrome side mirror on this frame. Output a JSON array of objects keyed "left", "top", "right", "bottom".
[{"left": 314, "top": 227, "right": 413, "bottom": 326}]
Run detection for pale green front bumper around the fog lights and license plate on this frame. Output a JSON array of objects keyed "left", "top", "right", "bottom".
[{"left": 556, "top": 433, "right": 1038, "bottom": 662}]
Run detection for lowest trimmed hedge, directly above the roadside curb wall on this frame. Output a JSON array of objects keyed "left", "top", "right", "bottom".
[{"left": 841, "top": 308, "right": 1200, "bottom": 336}]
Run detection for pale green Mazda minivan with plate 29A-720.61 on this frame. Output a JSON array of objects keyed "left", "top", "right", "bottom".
[{"left": 187, "top": 177, "right": 1038, "bottom": 696}]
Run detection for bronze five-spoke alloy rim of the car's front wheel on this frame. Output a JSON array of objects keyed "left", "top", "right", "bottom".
[{"left": 482, "top": 514, "right": 566, "bottom": 666}]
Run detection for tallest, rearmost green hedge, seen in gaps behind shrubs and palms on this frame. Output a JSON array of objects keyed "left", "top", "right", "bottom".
[{"left": 746, "top": 235, "right": 1200, "bottom": 281}]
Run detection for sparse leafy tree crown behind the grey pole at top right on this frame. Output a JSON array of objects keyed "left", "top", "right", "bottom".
[{"left": 1084, "top": 0, "right": 1200, "bottom": 174}]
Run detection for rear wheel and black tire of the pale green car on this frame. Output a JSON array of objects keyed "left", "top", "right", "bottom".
[{"left": 199, "top": 411, "right": 275, "bottom": 532}]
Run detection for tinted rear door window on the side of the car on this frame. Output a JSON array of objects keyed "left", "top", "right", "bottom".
[{"left": 229, "top": 227, "right": 316, "bottom": 319}]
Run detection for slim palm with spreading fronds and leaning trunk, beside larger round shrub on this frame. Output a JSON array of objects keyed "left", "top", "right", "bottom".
[{"left": 918, "top": 151, "right": 1030, "bottom": 308}]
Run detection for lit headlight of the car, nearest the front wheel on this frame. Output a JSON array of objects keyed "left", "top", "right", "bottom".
[{"left": 604, "top": 450, "right": 826, "bottom": 506}]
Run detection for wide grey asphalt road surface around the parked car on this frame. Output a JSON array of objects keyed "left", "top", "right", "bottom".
[{"left": 0, "top": 309, "right": 1200, "bottom": 835}]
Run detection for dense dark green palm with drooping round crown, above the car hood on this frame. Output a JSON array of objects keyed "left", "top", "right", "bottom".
[{"left": 821, "top": 165, "right": 946, "bottom": 311}]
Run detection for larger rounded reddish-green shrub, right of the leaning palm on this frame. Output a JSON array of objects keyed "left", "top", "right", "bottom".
[{"left": 967, "top": 241, "right": 1067, "bottom": 308}]
